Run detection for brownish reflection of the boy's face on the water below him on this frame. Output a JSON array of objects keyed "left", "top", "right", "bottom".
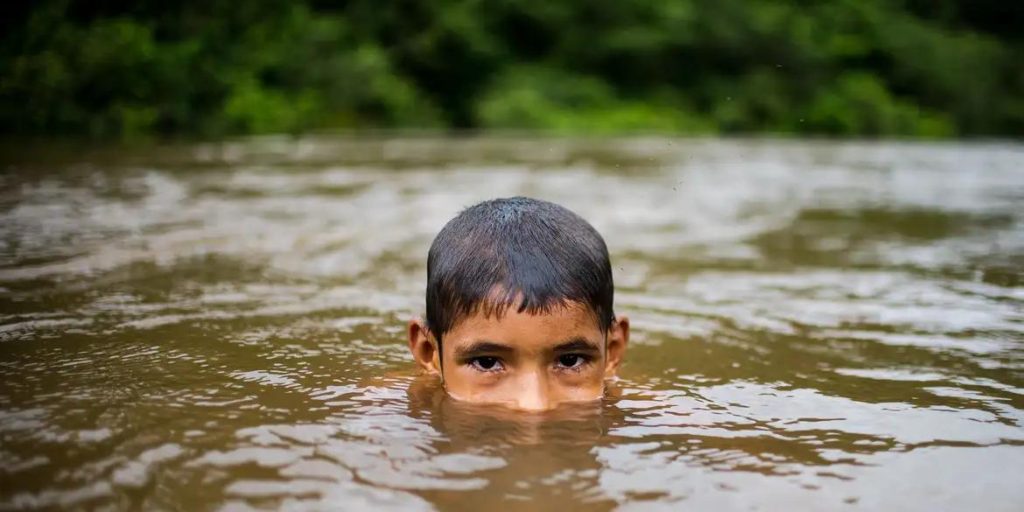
[{"left": 409, "top": 375, "right": 625, "bottom": 510}]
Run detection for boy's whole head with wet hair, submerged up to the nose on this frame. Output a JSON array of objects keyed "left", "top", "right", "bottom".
[{"left": 409, "top": 198, "right": 629, "bottom": 410}]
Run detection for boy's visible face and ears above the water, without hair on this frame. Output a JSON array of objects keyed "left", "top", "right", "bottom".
[{"left": 409, "top": 303, "right": 630, "bottom": 412}]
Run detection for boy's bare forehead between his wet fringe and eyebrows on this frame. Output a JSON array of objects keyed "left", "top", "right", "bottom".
[{"left": 444, "top": 302, "right": 603, "bottom": 348}]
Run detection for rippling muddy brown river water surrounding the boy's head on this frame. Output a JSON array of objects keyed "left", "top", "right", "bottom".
[{"left": 0, "top": 136, "right": 1024, "bottom": 511}]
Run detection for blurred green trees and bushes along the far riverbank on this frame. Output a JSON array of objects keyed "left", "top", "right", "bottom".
[{"left": 0, "top": 0, "right": 1024, "bottom": 136}]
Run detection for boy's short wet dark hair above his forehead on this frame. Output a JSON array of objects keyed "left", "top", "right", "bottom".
[{"left": 427, "top": 197, "right": 614, "bottom": 342}]
